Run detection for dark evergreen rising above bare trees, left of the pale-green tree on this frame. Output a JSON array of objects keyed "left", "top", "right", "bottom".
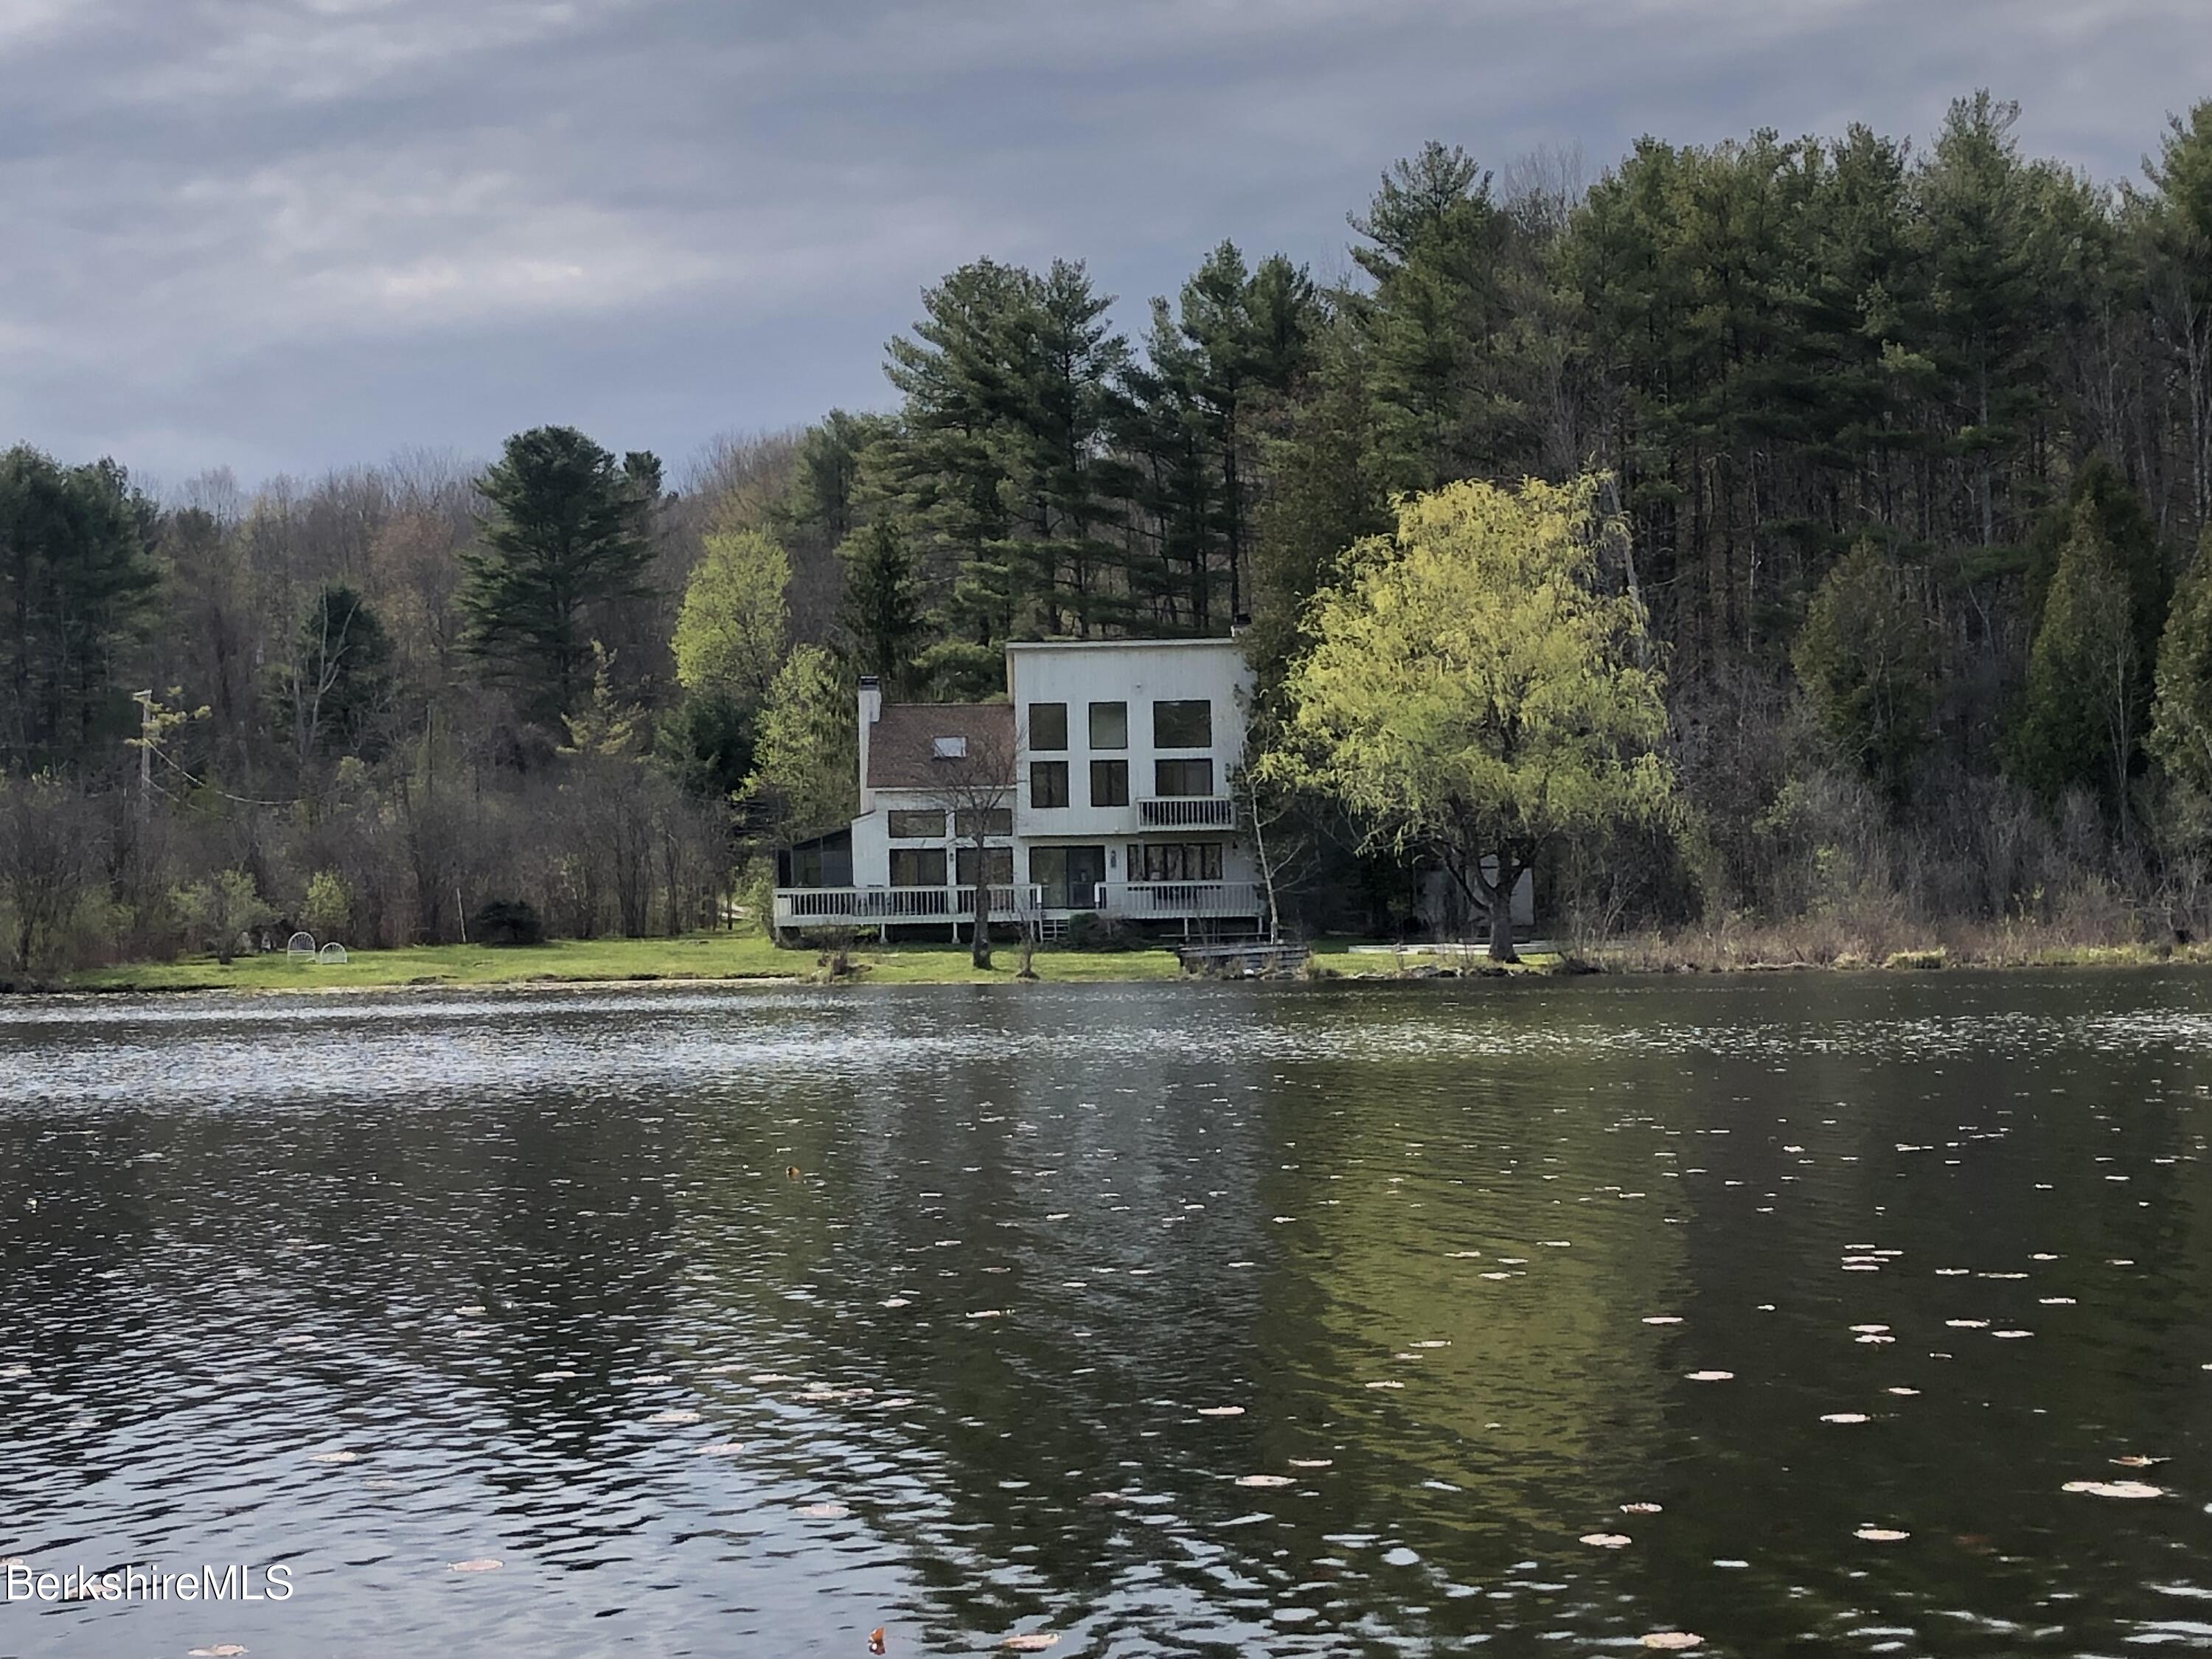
[{"left": 456, "top": 427, "right": 659, "bottom": 726}]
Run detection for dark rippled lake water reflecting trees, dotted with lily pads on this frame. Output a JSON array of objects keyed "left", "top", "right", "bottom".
[{"left": 0, "top": 973, "right": 2212, "bottom": 1657}]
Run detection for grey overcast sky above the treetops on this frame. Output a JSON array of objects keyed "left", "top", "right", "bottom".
[{"left": 0, "top": 0, "right": 2212, "bottom": 484}]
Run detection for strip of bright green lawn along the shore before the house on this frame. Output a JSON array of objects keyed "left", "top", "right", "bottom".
[{"left": 69, "top": 933, "right": 1179, "bottom": 991}]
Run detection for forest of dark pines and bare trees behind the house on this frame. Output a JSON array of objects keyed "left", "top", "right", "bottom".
[{"left": 0, "top": 93, "right": 2212, "bottom": 982}]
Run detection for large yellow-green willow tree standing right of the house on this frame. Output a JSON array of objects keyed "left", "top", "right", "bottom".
[{"left": 1263, "top": 478, "right": 1672, "bottom": 962}]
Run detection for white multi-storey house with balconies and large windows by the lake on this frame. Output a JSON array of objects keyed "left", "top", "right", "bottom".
[{"left": 774, "top": 639, "right": 1265, "bottom": 936}]
